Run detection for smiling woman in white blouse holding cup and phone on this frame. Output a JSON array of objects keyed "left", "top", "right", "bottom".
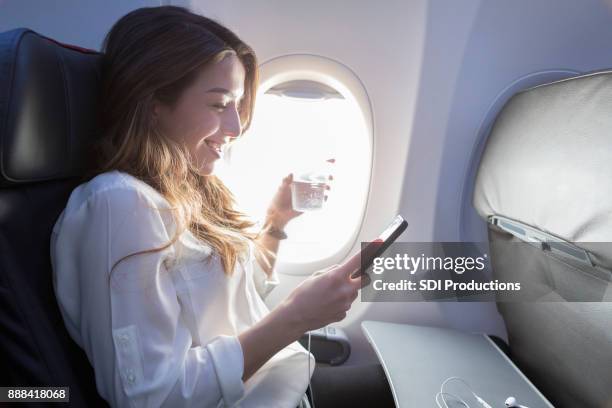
[{"left": 51, "top": 6, "right": 394, "bottom": 407}]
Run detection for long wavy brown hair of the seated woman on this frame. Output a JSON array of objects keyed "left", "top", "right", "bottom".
[{"left": 86, "top": 6, "right": 273, "bottom": 274}]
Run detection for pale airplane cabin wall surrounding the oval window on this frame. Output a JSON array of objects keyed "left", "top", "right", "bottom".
[{"left": 0, "top": 0, "right": 612, "bottom": 364}]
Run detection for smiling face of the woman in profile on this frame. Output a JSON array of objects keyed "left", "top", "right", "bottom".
[{"left": 154, "top": 53, "right": 246, "bottom": 175}]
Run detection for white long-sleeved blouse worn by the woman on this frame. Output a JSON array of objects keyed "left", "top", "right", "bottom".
[{"left": 51, "top": 171, "right": 315, "bottom": 408}]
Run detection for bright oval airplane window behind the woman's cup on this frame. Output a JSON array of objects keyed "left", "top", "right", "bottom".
[{"left": 217, "top": 80, "right": 372, "bottom": 263}]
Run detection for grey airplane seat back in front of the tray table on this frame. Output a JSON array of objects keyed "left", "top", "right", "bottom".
[{"left": 473, "top": 71, "right": 612, "bottom": 407}]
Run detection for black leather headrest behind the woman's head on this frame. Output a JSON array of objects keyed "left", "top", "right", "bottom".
[{"left": 0, "top": 28, "right": 101, "bottom": 187}]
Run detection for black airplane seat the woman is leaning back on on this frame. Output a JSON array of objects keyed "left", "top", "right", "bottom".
[{"left": 0, "top": 28, "right": 108, "bottom": 407}]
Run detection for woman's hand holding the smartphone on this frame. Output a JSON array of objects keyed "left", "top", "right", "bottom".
[{"left": 283, "top": 253, "right": 362, "bottom": 332}]
